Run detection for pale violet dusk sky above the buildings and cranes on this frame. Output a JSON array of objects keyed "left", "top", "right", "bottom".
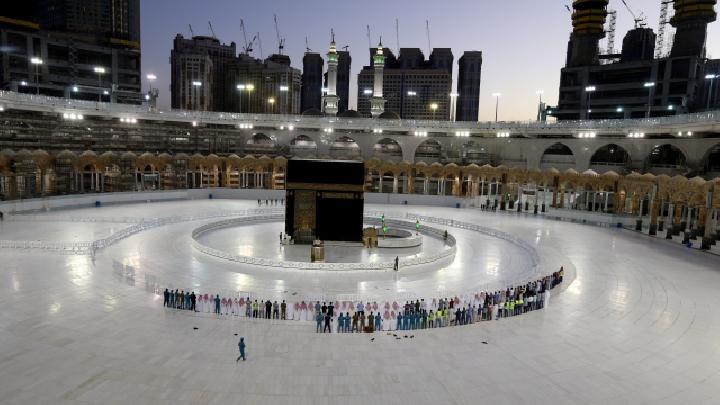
[{"left": 142, "top": 0, "right": 720, "bottom": 121}]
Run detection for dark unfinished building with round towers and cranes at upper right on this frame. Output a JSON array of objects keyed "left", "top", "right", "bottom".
[{"left": 547, "top": 0, "right": 717, "bottom": 120}]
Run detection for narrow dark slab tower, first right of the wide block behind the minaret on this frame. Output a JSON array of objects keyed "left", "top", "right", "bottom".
[{"left": 455, "top": 51, "right": 482, "bottom": 121}]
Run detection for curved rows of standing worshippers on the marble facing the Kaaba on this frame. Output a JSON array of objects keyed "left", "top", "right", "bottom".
[{"left": 163, "top": 267, "right": 564, "bottom": 332}]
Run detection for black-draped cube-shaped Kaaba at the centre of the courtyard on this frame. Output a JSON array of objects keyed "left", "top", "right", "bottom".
[{"left": 285, "top": 159, "right": 365, "bottom": 244}]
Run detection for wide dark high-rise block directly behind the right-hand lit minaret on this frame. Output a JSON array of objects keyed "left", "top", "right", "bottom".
[{"left": 357, "top": 46, "right": 453, "bottom": 120}]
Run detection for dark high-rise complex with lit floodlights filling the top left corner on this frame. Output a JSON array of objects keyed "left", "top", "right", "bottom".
[{"left": 0, "top": 0, "right": 141, "bottom": 103}]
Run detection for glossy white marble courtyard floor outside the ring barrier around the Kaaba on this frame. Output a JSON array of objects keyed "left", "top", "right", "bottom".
[{"left": 0, "top": 200, "right": 720, "bottom": 404}]
